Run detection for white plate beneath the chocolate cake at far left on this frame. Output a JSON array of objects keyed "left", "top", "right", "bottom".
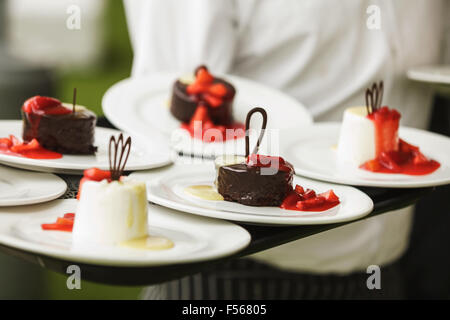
[{"left": 0, "top": 120, "right": 171, "bottom": 174}]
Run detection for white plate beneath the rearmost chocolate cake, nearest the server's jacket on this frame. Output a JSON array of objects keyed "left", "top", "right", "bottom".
[{"left": 102, "top": 73, "right": 312, "bottom": 156}]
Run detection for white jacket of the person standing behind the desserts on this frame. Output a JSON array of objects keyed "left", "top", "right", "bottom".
[{"left": 124, "top": 0, "right": 448, "bottom": 273}]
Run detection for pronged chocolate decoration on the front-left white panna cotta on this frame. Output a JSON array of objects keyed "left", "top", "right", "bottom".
[{"left": 108, "top": 134, "right": 131, "bottom": 181}]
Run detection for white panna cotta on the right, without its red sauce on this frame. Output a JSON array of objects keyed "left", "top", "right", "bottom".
[{"left": 337, "top": 107, "right": 376, "bottom": 166}]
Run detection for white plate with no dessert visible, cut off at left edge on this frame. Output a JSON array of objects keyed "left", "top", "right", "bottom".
[{"left": 0, "top": 165, "right": 67, "bottom": 207}]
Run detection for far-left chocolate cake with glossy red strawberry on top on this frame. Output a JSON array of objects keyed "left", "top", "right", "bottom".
[{"left": 22, "top": 96, "right": 97, "bottom": 154}]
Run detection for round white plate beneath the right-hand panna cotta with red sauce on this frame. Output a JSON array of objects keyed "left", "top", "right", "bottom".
[{"left": 280, "top": 123, "right": 450, "bottom": 188}]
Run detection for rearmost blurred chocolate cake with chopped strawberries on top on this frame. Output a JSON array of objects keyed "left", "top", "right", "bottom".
[{"left": 170, "top": 66, "right": 236, "bottom": 125}]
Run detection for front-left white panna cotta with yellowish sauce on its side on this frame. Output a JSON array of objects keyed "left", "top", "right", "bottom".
[{"left": 73, "top": 178, "right": 148, "bottom": 245}]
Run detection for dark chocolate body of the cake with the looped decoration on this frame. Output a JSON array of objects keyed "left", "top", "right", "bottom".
[{"left": 217, "top": 162, "right": 294, "bottom": 206}]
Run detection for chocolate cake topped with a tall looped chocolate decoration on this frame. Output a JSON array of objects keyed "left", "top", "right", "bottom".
[{"left": 216, "top": 108, "right": 294, "bottom": 206}]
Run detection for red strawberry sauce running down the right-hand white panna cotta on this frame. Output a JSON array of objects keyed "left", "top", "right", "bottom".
[{"left": 360, "top": 107, "right": 440, "bottom": 176}]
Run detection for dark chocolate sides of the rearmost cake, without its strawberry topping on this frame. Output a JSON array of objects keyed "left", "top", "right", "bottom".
[{"left": 170, "top": 78, "right": 236, "bottom": 126}]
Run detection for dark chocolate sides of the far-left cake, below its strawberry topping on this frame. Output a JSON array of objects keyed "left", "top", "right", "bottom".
[{"left": 22, "top": 110, "right": 97, "bottom": 154}]
